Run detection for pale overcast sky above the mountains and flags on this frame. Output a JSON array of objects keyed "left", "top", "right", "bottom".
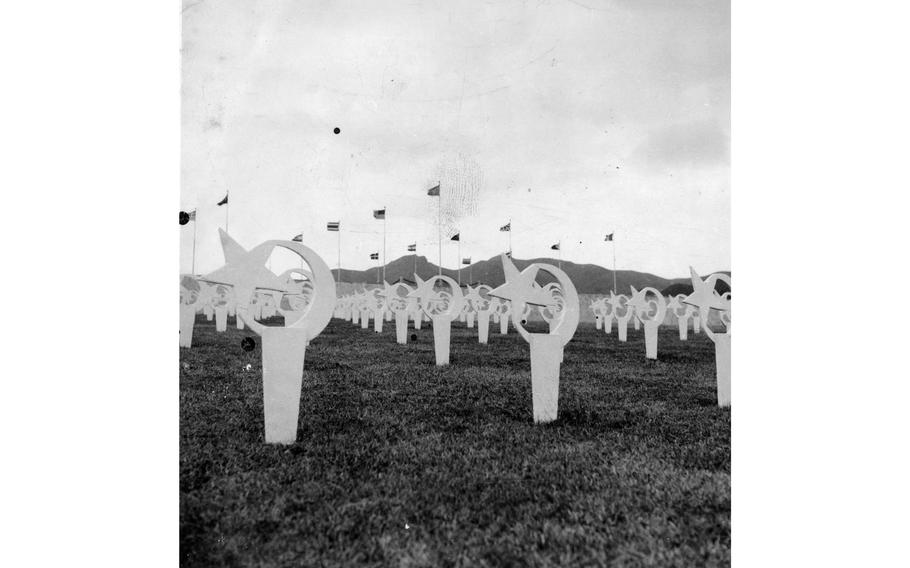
[{"left": 180, "top": 0, "right": 731, "bottom": 277}]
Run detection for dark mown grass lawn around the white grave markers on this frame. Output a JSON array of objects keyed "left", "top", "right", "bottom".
[{"left": 180, "top": 316, "right": 730, "bottom": 567}]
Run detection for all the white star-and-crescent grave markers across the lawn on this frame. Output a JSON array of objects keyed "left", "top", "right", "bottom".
[{"left": 180, "top": 230, "right": 731, "bottom": 444}]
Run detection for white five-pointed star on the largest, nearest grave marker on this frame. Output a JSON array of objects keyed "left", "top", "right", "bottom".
[{"left": 202, "top": 229, "right": 293, "bottom": 302}]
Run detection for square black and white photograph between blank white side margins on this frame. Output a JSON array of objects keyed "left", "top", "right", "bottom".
[{"left": 180, "top": 0, "right": 732, "bottom": 566}]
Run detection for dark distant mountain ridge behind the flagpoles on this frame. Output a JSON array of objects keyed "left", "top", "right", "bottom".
[{"left": 332, "top": 254, "right": 729, "bottom": 294}]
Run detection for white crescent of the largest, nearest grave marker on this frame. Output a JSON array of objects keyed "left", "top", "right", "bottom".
[{"left": 242, "top": 240, "right": 336, "bottom": 341}]
